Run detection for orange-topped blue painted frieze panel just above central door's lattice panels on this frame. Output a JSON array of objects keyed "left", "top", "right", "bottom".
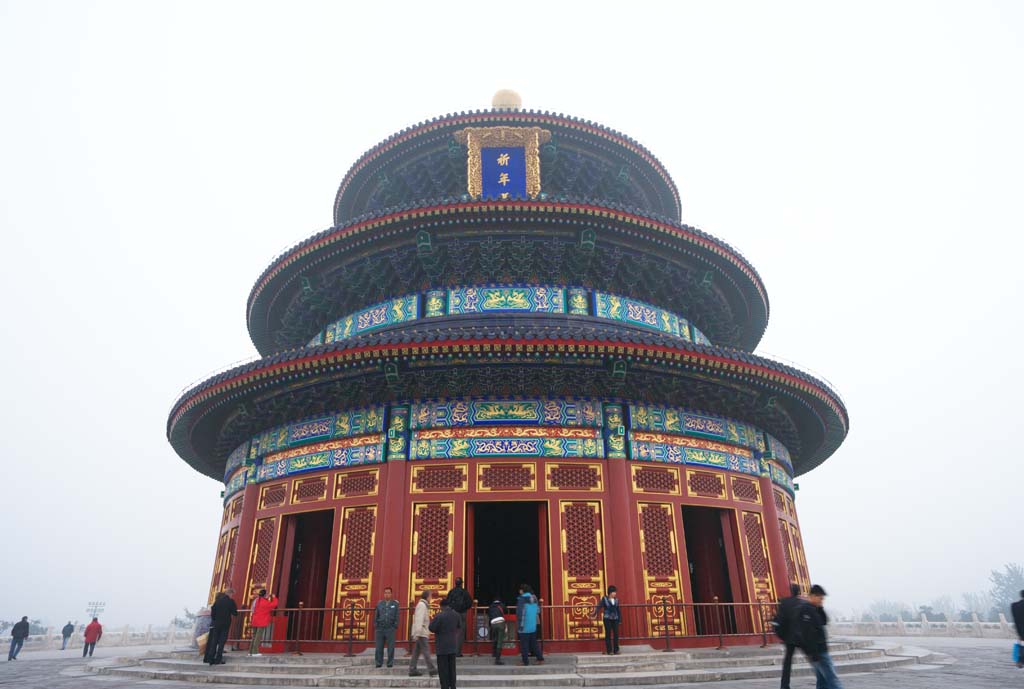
[{"left": 409, "top": 426, "right": 604, "bottom": 460}]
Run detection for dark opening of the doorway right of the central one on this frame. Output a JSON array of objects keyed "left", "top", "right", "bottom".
[{"left": 683, "top": 507, "right": 735, "bottom": 634}]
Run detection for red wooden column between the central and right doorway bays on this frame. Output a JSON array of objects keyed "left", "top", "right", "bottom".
[{"left": 604, "top": 459, "right": 646, "bottom": 603}]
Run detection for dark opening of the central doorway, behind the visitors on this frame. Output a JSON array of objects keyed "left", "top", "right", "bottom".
[{"left": 470, "top": 503, "right": 541, "bottom": 606}]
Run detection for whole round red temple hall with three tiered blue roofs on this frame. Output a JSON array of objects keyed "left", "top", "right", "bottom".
[{"left": 167, "top": 92, "right": 849, "bottom": 650}]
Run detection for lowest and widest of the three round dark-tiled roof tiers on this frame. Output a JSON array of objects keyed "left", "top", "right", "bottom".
[{"left": 167, "top": 322, "right": 849, "bottom": 479}]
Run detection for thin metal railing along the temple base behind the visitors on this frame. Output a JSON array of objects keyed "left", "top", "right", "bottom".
[{"left": 228, "top": 598, "right": 775, "bottom": 655}]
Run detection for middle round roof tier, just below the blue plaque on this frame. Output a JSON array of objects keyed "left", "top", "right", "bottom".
[{"left": 247, "top": 199, "right": 768, "bottom": 355}]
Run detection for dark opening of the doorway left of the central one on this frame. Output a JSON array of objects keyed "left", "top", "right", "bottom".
[{"left": 282, "top": 510, "right": 334, "bottom": 608}]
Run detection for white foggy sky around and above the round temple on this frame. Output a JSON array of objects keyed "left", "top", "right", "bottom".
[{"left": 0, "top": 0, "right": 1024, "bottom": 623}]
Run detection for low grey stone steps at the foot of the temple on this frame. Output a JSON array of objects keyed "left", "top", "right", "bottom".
[{"left": 89, "top": 640, "right": 948, "bottom": 689}]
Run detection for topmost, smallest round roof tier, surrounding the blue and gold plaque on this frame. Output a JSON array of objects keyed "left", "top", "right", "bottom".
[{"left": 334, "top": 110, "right": 681, "bottom": 225}]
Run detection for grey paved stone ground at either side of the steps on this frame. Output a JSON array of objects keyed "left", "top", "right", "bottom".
[{"left": 0, "top": 637, "right": 1024, "bottom": 689}]
